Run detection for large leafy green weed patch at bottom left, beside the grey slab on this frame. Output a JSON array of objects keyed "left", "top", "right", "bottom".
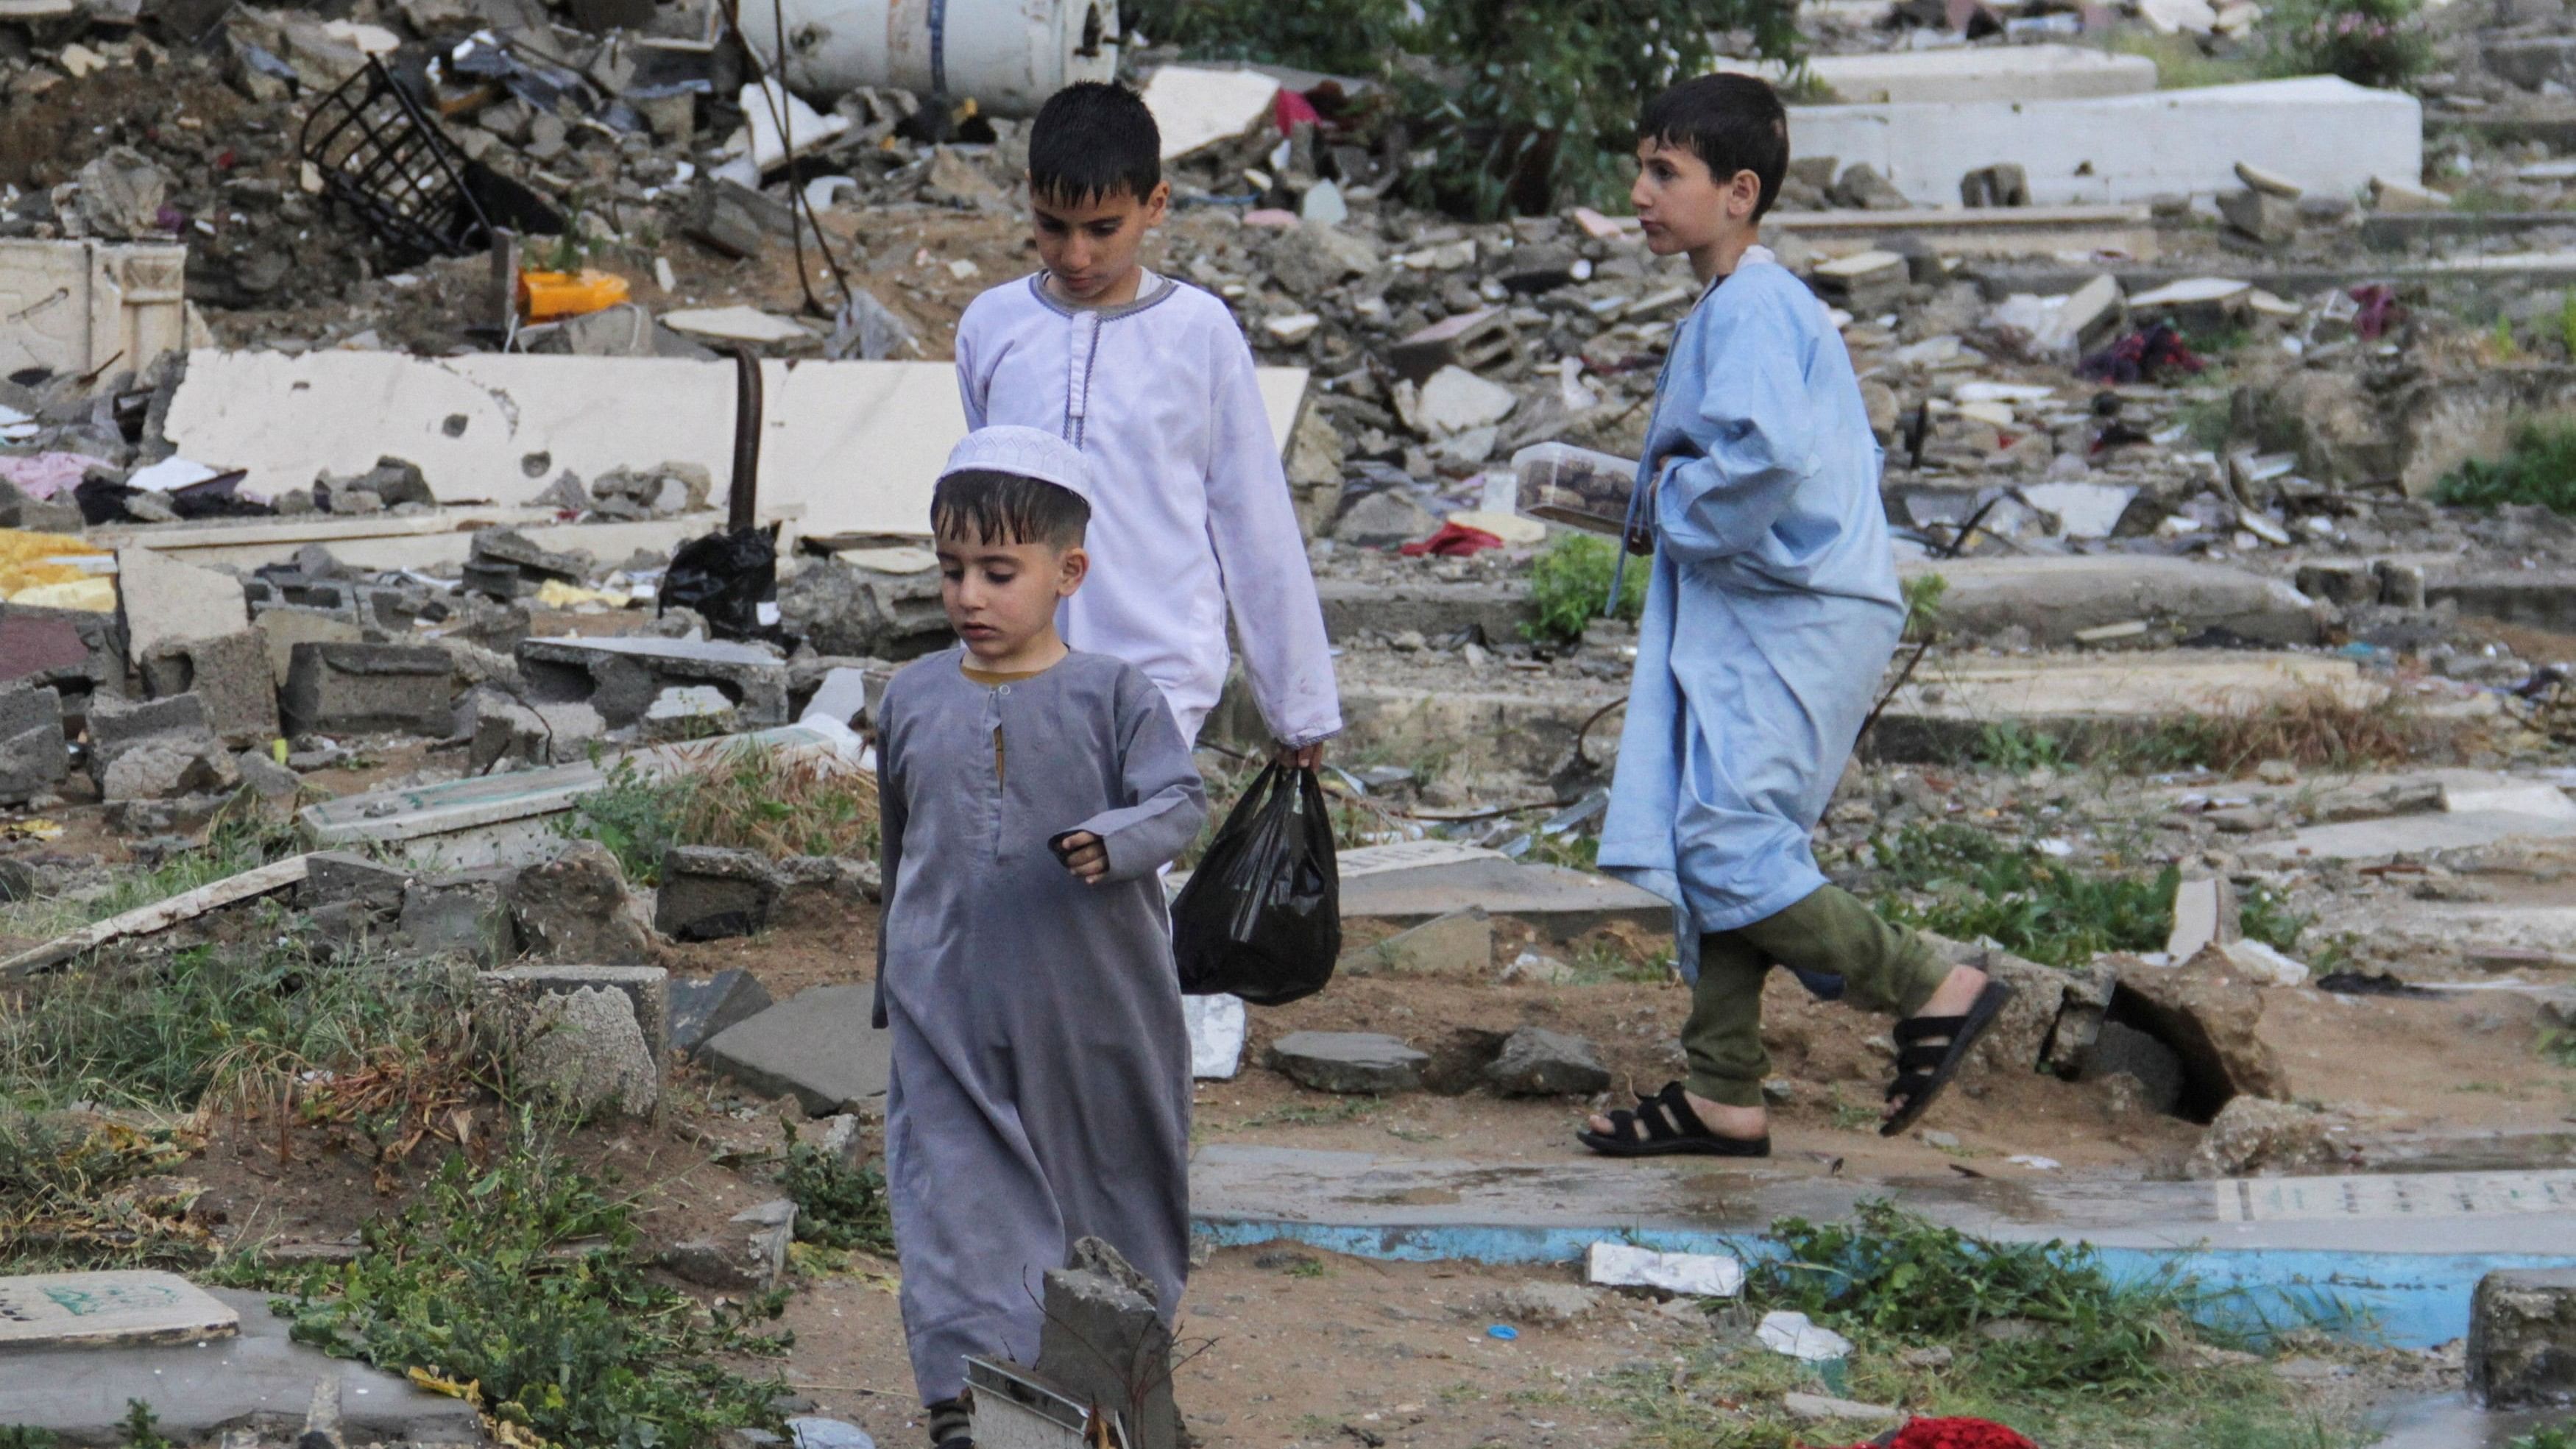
[{"left": 232, "top": 1122, "right": 788, "bottom": 1449}]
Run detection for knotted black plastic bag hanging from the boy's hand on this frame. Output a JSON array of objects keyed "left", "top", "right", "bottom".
[{"left": 1172, "top": 765, "right": 1342, "bottom": 1006}]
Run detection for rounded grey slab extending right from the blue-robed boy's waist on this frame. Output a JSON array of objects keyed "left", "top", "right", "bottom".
[{"left": 1899, "top": 553, "right": 2324, "bottom": 643}]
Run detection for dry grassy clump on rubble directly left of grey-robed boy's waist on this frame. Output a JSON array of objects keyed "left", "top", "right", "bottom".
[{"left": 556, "top": 744, "right": 876, "bottom": 885}]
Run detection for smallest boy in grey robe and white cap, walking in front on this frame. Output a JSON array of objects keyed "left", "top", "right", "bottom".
[{"left": 876, "top": 428, "right": 1206, "bottom": 1449}]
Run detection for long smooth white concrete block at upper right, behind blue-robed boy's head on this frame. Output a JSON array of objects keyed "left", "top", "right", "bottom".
[{"left": 1788, "top": 77, "right": 2424, "bottom": 206}]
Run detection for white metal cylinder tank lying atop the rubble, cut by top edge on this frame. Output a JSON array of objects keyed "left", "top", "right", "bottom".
[{"left": 742, "top": 0, "right": 1118, "bottom": 116}]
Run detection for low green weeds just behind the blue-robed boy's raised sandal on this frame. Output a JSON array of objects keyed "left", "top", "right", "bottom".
[{"left": 1870, "top": 821, "right": 2182, "bottom": 966}]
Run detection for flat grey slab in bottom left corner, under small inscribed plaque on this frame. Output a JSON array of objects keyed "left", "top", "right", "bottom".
[{"left": 0, "top": 1289, "right": 482, "bottom": 1447}]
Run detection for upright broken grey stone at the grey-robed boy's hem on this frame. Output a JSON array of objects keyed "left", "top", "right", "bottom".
[{"left": 1038, "top": 1238, "right": 1183, "bottom": 1449}]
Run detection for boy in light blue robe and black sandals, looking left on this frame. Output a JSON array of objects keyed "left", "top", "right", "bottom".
[{"left": 1579, "top": 74, "right": 2012, "bottom": 1155}]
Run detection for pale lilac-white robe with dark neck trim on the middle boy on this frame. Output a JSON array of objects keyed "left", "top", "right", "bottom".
[{"left": 956, "top": 273, "right": 1342, "bottom": 744}]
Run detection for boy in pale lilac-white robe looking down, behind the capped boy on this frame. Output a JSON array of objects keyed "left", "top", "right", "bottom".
[{"left": 956, "top": 82, "right": 1342, "bottom": 765}]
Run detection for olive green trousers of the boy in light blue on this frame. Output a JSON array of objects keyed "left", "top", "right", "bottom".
[{"left": 1682, "top": 885, "right": 1950, "bottom": 1107}]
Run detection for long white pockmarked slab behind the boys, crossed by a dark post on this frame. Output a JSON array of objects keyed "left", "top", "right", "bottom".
[{"left": 160, "top": 355, "right": 1306, "bottom": 545}]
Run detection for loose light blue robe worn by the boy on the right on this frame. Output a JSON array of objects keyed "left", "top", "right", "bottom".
[{"left": 1600, "top": 252, "right": 1904, "bottom": 952}]
